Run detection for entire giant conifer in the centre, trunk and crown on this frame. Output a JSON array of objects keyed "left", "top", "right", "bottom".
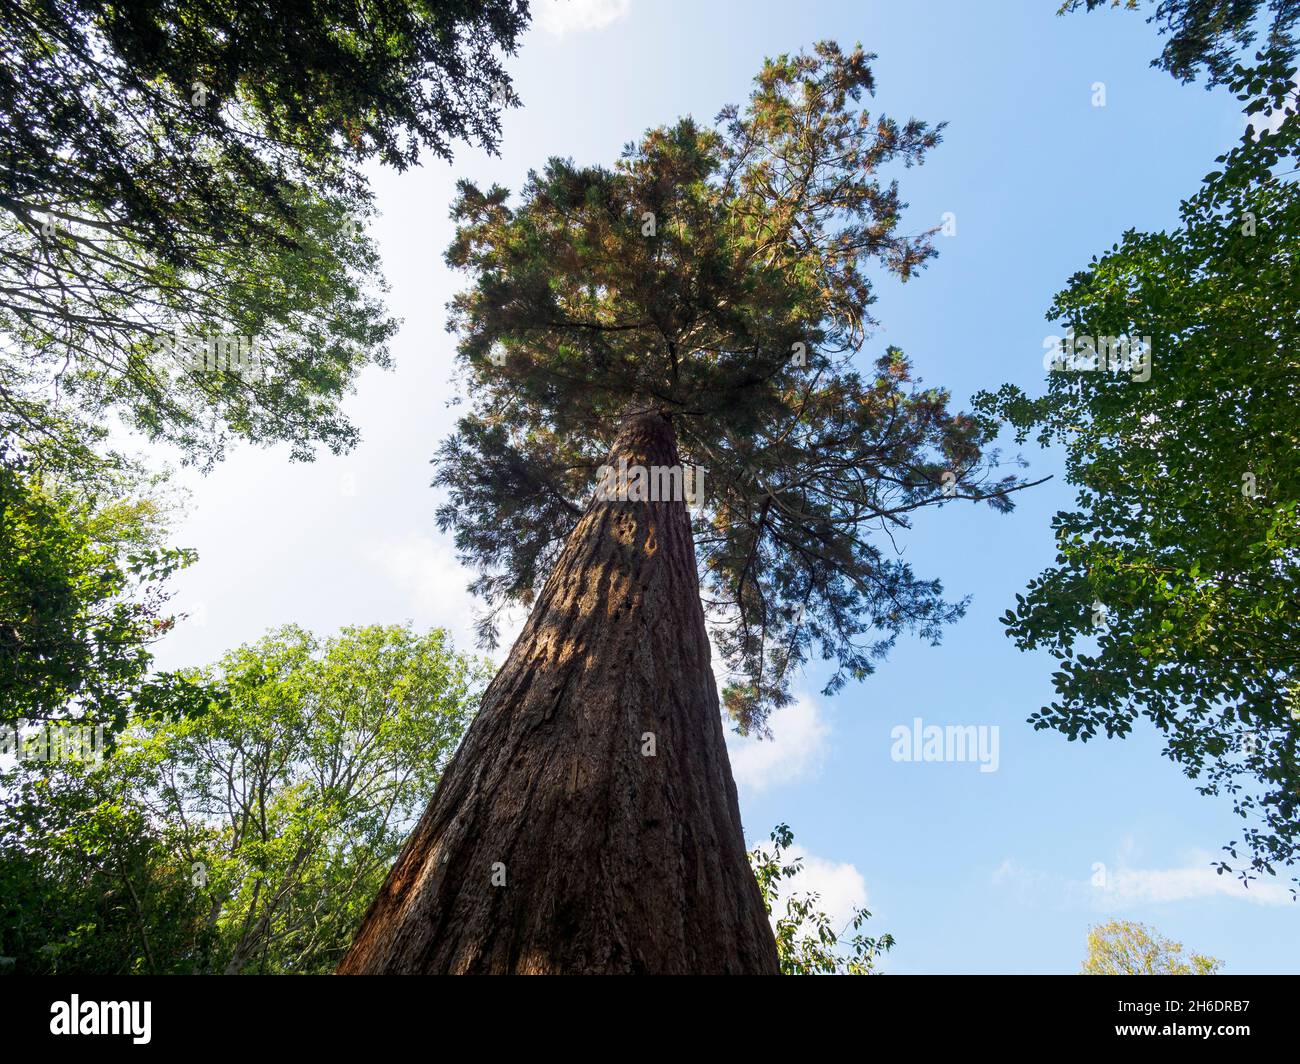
[{"left": 341, "top": 43, "right": 1015, "bottom": 972}]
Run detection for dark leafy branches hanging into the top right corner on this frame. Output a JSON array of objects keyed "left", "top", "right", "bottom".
[{"left": 1058, "top": 0, "right": 1300, "bottom": 88}]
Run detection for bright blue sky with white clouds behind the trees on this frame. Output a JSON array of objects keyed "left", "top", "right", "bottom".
[{"left": 144, "top": 0, "right": 1300, "bottom": 973}]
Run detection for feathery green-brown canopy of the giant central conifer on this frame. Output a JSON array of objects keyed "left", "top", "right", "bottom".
[{"left": 436, "top": 43, "right": 1015, "bottom": 727}]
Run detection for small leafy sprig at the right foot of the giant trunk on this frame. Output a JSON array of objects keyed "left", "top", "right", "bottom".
[{"left": 749, "top": 823, "right": 894, "bottom": 976}]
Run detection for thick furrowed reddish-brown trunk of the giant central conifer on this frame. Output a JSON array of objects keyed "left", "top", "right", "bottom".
[{"left": 338, "top": 414, "right": 777, "bottom": 974}]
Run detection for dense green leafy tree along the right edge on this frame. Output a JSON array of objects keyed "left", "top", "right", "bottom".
[{"left": 978, "top": 56, "right": 1300, "bottom": 879}]
